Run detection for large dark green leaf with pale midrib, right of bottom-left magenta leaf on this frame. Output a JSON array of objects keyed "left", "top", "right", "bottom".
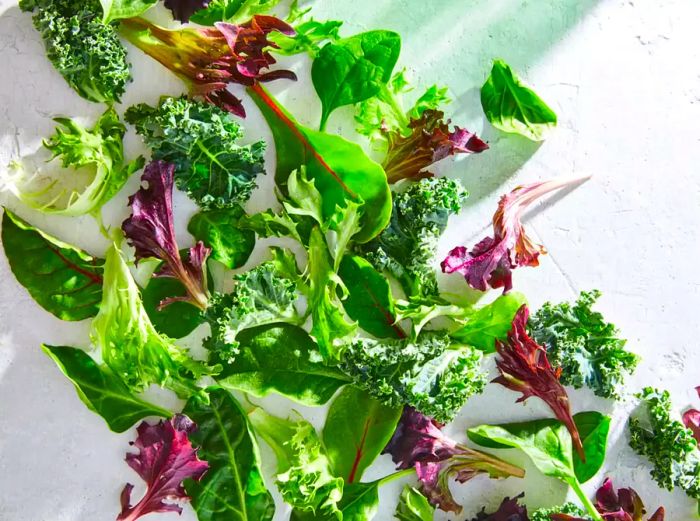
[{"left": 182, "top": 388, "right": 275, "bottom": 521}]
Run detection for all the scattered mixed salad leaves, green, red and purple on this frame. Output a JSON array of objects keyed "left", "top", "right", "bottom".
[{"left": 2, "top": 0, "right": 700, "bottom": 521}]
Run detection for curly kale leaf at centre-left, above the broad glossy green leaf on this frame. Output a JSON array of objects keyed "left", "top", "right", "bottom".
[{"left": 205, "top": 262, "right": 300, "bottom": 362}]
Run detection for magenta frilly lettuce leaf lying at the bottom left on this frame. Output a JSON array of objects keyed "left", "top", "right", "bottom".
[{"left": 117, "top": 414, "right": 209, "bottom": 521}]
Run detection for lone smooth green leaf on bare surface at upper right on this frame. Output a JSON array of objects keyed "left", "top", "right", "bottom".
[{"left": 481, "top": 60, "right": 557, "bottom": 141}]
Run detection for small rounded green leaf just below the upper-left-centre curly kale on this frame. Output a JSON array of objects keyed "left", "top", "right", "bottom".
[{"left": 187, "top": 206, "right": 255, "bottom": 270}]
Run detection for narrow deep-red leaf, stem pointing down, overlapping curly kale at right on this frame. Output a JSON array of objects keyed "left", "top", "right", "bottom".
[{"left": 493, "top": 304, "right": 585, "bottom": 461}]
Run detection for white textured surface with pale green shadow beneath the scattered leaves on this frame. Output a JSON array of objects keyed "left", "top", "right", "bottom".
[{"left": 0, "top": 0, "right": 700, "bottom": 521}]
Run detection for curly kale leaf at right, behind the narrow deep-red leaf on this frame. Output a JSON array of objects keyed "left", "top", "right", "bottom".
[{"left": 528, "top": 290, "right": 638, "bottom": 399}]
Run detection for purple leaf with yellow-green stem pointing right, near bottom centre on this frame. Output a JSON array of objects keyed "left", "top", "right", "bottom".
[{"left": 384, "top": 407, "right": 524, "bottom": 513}]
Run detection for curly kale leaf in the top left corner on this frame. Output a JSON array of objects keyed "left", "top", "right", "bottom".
[{"left": 20, "top": 0, "right": 131, "bottom": 103}]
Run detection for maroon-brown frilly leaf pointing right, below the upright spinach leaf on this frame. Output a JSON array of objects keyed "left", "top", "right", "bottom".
[{"left": 383, "top": 109, "right": 489, "bottom": 183}]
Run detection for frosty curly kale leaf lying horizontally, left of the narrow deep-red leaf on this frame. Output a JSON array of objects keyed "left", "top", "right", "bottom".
[{"left": 341, "top": 333, "right": 486, "bottom": 422}]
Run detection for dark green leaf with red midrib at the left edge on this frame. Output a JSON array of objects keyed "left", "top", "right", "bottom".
[{"left": 2, "top": 208, "right": 104, "bottom": 320}]
